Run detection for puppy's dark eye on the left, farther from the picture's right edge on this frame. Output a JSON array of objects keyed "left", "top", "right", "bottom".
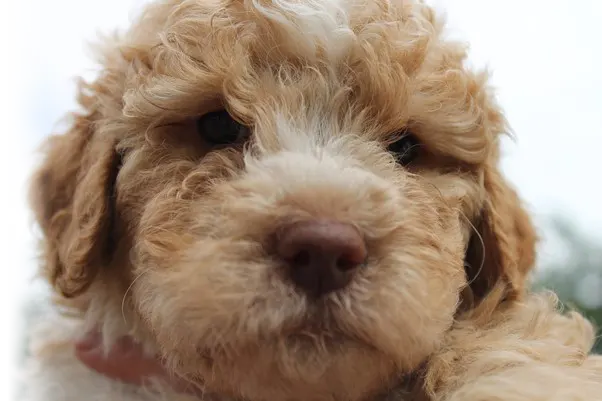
[{"left": 196, "top": 110, "right": 249, "bottom": 145}]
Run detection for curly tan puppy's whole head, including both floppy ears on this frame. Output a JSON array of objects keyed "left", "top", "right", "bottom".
[{"left": 28, "top": 0, "right": 533, "bottom": 400}]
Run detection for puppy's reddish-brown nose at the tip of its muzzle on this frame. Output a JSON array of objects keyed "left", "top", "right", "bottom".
[{"left": 276, "top": 220, "right": 367, "bottom": 297}]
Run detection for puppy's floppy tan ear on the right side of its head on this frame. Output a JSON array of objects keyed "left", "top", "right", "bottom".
[{"left": 464, "top": 164, "right": 537, "bottom": 307}]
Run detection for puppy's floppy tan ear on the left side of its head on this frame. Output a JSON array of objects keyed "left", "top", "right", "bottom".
[{"left": 27, "top": 85, "right": 120, "bottom": 297}]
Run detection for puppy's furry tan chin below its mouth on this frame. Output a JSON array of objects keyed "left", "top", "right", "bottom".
[{"left": 188, "top": 329, "right": 399, "bottom": 400}]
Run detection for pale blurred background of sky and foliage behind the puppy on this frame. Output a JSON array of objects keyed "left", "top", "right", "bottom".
[{"left": 5, "top": 0, "right": 602, "bottom": 399}]
